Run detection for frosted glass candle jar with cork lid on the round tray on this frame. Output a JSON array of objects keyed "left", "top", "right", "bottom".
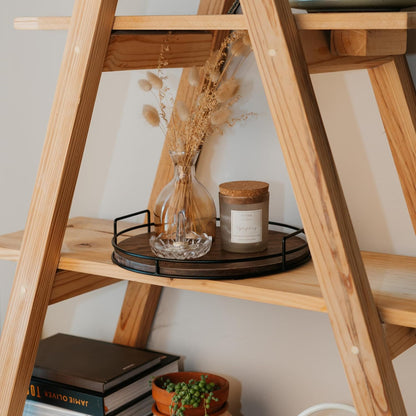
[{"left": 219, "top": 181, "right": 269, "bottom": 253}]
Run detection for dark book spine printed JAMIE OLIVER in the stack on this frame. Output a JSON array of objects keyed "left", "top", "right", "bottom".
[{"left": 27, "top": 377, "right": 105, "bottom": 416}]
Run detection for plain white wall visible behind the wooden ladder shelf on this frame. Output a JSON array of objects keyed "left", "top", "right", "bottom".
[{"left": 0, "top": 0, "right": 416, "bottom": 416}]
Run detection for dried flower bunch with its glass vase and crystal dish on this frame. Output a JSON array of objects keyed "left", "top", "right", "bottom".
[{"left": 139, "top": 31, "right": 251, "bottom": 259}]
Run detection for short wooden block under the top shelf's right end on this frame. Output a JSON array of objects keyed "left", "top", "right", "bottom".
[{"left": 331, "top": 30, "right": 407, "bottom": 56}]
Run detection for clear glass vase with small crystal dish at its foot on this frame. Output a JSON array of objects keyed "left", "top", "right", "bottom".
[{"left": 149, "top": 151, "right": 216, "bottom": 260}]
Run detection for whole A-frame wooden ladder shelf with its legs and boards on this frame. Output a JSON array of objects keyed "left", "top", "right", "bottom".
[{"left": 0, "top": 0, "right": 416, "bottom": 416}]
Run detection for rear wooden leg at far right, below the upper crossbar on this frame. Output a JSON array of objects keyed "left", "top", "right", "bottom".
[{"left": 368, "top": 56, "right": 416, "bottom": 231}]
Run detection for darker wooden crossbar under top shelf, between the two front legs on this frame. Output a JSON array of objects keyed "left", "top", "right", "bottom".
[{"left": 103, "top": 31, "right": 213, "bottom": 71}]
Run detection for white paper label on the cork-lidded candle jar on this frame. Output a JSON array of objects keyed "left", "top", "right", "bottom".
[{"left": 231, "top": 209, "right": 262, "bottom": 244}]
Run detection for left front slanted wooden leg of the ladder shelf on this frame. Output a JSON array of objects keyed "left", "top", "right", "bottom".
[{"left": 0, "top": 0, "right": 117, "bottom": 416}]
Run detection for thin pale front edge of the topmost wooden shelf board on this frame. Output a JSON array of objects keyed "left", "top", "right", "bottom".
[{"left": 14, "top": 12, "right": 416, "bottom": 30}]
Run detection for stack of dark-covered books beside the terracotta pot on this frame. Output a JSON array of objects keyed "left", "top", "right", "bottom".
[{"left": 23, "top": 334, "right": 179, "bottom": 416}]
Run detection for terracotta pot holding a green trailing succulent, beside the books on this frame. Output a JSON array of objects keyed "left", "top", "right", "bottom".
[{"left": 152, "top": 371, "right": 229, "bottom": 416}]
